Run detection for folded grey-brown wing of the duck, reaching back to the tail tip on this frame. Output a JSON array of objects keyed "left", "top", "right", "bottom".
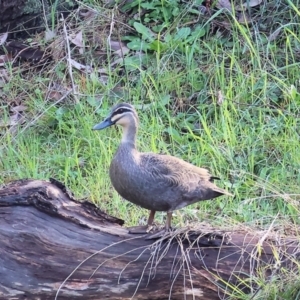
[{"left": 140, "top": 153, "right": 232, "bottom": 210}]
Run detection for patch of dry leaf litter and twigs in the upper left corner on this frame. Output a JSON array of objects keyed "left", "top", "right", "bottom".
[{"left": 0, "top": 7, "right": 130, "bottom": 128}]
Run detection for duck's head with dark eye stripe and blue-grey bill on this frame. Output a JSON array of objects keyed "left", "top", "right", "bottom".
[{"left": 93, "top": 103, "right": 138, "bottom": 130}]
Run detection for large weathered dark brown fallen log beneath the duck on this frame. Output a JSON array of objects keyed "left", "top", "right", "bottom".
[{"left": 0, "top": 180, "right": 298, "bottom": 300}]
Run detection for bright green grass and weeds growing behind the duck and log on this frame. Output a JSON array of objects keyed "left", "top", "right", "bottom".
[{"left": 0, "top": 0, "right": 300, "bottom": 299}]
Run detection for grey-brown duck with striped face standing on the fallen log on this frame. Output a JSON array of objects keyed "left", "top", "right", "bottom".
[{"left": 93, "top": 103, "right": 233, "bottom": 233}]
